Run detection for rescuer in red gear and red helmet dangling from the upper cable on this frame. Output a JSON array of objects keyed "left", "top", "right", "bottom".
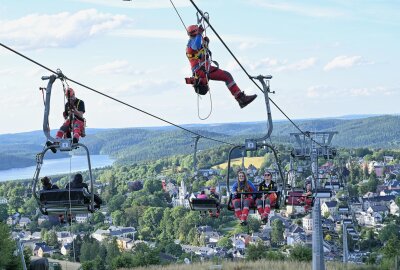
[{"left": 186, "top": 25, "right": 257, "bottom": 108}]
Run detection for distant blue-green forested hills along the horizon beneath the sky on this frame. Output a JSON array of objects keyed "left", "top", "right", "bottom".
[{"left": 0, "top": 115, "right": 400, "bottom": 169}]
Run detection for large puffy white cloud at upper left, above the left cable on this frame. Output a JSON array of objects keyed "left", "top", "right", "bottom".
[{"left": 0, "top": 9, "right": 132, "bottom": 49}]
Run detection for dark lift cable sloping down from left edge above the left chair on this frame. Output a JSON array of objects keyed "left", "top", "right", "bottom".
[{"left": 0, "top": 42, "right": 234, "bottom": 145}]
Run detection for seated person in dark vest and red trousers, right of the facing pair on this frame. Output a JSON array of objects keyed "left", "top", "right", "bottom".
[{"left": 256, "top": 171, "right": 278, "bottom": 224}]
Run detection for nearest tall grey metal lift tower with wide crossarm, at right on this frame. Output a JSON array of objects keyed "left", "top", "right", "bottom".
[{"left": 290, "top": 131, "right": 338, "bottom": 270}]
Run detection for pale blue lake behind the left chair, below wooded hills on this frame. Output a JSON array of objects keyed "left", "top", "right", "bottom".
[{"left": 0, "top": 155, "right": 114, "bottom": 182}]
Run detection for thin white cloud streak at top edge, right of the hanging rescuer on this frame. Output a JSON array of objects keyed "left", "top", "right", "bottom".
[{"left": 251, "top": 0, "right": 345, "bottom": 18}]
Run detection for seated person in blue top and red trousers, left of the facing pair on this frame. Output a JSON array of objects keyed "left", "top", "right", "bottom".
[{"left": 231, "top": 171, "right": 256, "bottom": 225}]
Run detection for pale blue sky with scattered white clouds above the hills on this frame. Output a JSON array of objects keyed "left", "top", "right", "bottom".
[{"left": 0, "top": 0, "right": 400, "bottom": 134}]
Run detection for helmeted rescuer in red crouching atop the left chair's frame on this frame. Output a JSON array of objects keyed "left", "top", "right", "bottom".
[{"left": 46, "top": 88, "right": 85, "bottom": 153}]
